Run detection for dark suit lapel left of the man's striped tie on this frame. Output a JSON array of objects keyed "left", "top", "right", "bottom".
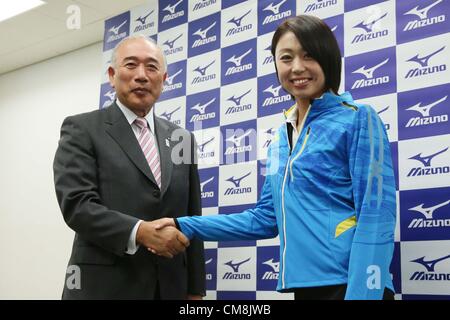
[{"left": 105, "top": 103, "right": 157, "bottom": 186}]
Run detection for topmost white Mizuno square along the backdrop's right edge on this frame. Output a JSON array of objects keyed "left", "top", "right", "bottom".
[{"left": 397, "top": 33, "right": 450, "bottom": 92}]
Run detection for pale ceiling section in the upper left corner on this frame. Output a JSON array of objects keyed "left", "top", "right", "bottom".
[{"left": 0, "top": 0, "right": 151, "bottom": 74}]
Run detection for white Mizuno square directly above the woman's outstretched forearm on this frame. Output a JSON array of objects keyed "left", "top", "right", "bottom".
[{"left": 219, "top": 161, "right": 258, "bottom": 206}]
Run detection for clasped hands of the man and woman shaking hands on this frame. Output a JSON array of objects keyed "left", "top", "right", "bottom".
[{"left": 136, "top": 218, "right": 189, "bottom": 258}]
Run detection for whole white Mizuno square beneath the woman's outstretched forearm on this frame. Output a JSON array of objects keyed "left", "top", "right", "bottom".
[{"left": 217, "top": 247, "right": 256, "bottom": 291}]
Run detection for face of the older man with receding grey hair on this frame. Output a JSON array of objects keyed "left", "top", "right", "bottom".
[{"left": 108, "top": 39, "right": 167, "bottom": 116}]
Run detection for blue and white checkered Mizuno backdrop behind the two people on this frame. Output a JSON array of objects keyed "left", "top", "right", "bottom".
[{"left": 100, "top": 0, "right": 450, "bottom": 299}]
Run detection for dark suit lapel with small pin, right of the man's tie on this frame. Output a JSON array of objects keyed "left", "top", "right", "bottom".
[{"left": 154, "top": 116, "right": 173, "bottom": 196}]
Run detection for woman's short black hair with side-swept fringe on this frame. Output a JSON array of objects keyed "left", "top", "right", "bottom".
[{"left": 271, "top": 14, "right": 342, "bottom": 94}]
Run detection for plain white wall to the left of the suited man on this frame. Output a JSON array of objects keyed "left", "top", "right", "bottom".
[{"left": 0, "top": 43, "right": 102, "bottom": 299}]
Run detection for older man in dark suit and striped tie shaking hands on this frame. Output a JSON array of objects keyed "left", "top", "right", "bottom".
[{"left": 54, "top": 36, "right": 205, "bottom": 299}]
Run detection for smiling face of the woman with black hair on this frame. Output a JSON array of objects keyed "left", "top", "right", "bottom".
[{"left": 275, "top": 31, "right": 325, "bottom": 105}]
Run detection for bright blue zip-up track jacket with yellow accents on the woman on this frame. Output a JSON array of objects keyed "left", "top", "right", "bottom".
[{"left": 177, "top": 93, "right": 396, "bottom": 299}]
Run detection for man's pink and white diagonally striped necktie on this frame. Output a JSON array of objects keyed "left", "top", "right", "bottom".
[{"left": 134, "top": 118, "right": 161, "bottom": 188}]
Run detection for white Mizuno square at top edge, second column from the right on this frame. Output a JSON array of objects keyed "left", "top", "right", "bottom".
[{"left": 344, "top": 1, "right": 396, "bottom": 56}]
